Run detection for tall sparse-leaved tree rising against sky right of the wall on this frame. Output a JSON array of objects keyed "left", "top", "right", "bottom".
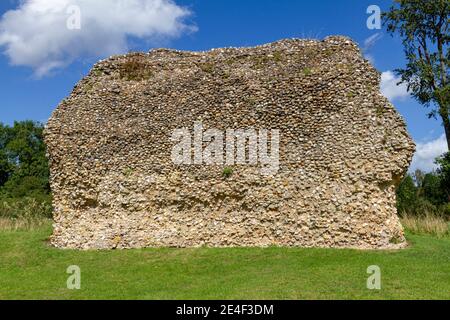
[{"left": 383, "top": 0, "right": 450, "bottom": 150}]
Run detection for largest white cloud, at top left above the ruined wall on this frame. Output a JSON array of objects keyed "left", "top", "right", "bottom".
[{"left": 0, "top": 0, "right": 196, "bottom": 76}]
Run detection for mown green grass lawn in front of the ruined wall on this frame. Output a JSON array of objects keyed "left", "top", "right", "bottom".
[{"left": 0, "top": 222, "right": 450, "bottom": 299}]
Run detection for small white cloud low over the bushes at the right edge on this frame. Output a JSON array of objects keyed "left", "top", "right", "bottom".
[{"left": 410, "top": 135, "right": 448, "bottom": 172}]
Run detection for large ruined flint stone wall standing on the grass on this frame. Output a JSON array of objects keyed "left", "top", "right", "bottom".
[{"left": 45, "top": 37, "right": 414, "bottom": 249}]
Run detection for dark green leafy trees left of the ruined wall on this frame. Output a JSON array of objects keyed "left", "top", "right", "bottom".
[{"left": 0, "top": 121, "right": 51, "bottom": 219}]
